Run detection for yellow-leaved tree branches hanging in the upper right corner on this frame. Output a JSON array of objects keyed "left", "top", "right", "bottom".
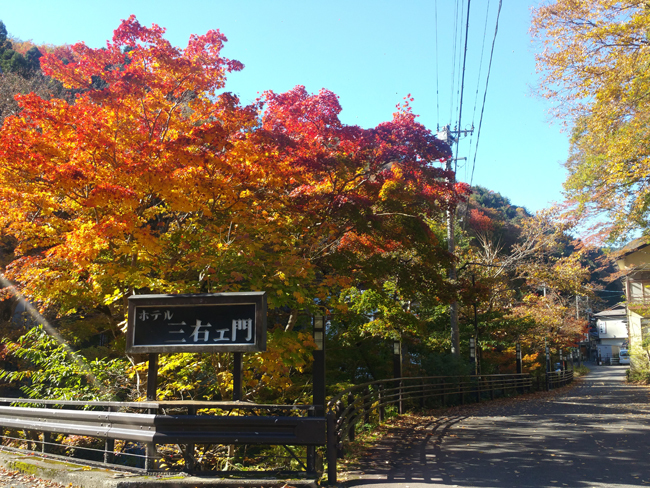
[{"left": 532, "top": 0, "right": 650, "bottom": 238}]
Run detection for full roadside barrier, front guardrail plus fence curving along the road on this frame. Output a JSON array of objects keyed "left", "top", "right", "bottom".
[{"left": 0, "top": 371, "right": 573, "bottom": 484}]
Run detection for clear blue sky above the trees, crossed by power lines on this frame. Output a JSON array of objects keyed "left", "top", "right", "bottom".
[{"left": 0, "top": 0, "right": 568, "bottom": 212}]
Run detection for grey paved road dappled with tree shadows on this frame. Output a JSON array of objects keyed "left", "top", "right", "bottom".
[{"left": 346, "top": 366, "right": 650, "bottom": 488}]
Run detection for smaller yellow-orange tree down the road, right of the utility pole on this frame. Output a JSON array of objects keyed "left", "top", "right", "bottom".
[{"left": 450, "top": 204, "right": 593, "bottom": 372}]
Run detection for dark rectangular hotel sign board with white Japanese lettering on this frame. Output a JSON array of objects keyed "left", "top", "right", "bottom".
[{"left": 126, "top": 292, "right": 266, "bottom": 354}]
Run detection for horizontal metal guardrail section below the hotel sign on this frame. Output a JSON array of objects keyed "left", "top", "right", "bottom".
[{"left": 0, "top": 398, "right": 326, "bottom": 472}]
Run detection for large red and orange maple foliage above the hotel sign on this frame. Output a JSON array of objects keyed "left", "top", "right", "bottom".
[{"left": 0, "top": 17, "right": 460, "bottom": 400}]
